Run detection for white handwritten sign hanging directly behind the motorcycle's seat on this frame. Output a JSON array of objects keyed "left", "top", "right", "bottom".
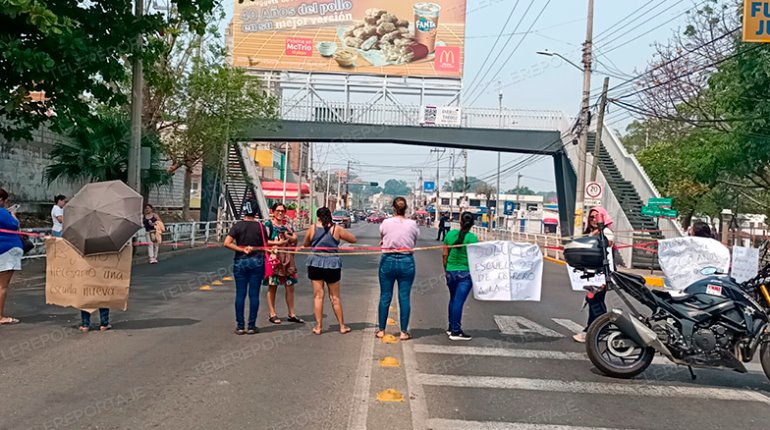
[{"left": 658, "top": 236, "right": 730, "bottom": 290}]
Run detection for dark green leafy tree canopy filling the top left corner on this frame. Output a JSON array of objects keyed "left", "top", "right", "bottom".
[{"left": 0, "top": 0, "right": 218, "bottom": 139}]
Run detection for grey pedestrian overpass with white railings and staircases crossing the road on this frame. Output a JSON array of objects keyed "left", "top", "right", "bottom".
[{"left": 216, "top": 99, "right": 682, "bottom": 267}]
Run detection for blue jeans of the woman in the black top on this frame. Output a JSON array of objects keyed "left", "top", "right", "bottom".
[{"left": 233, "top": 257, "right": 265, "bottom": 329}]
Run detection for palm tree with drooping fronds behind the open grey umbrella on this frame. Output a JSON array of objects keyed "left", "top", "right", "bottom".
[{"left": 45, "top": 112, "right": 170, "bottom": 200}]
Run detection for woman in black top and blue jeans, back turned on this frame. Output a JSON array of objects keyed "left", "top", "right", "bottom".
[{"left": 225, "top": 202, "right": 286, "bottom": 335}]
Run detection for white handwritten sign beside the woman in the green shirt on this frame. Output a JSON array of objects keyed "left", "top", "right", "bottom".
[{"left": 468, "top": 241, "right": 543, "bottom": 301}]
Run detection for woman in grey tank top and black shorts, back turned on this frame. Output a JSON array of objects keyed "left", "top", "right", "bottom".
[{"left": 304, "top": 207, "right": 356, "bottom": 334}]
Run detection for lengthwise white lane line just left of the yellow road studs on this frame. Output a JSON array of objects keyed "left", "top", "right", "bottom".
[{"left": 347, "top": 288, "right": 377, "bottom": 430}]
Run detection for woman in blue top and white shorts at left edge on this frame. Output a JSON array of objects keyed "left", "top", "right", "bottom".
[{"left": 0, "top": 188, "right": 24, "bottom": 325}]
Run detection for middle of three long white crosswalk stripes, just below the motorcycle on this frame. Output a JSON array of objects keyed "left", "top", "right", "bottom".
[{"left": 417, "top": 373, "right": 770, "bottom": 405}]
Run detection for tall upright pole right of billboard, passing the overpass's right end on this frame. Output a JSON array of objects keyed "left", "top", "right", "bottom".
[{"left": 572, "top": 0, "right": 594, "bottom": 237}]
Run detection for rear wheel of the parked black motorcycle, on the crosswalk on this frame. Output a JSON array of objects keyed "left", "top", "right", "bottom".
[{"left": 586, "top": 314, "right": 655, "bottom": 379}]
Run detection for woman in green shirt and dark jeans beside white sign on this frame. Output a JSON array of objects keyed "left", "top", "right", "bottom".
[{"left": 444, "top": 212, "right": 479, "bottom": 340}]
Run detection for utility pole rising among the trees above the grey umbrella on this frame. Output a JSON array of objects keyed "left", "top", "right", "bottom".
[{"left": 127, "top": 0, "right": 144, "bottom": 193}]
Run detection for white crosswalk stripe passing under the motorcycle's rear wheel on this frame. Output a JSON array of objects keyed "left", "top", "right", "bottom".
[{"left": 414, "top": 344, "right": 763, "bottom": 373}]
